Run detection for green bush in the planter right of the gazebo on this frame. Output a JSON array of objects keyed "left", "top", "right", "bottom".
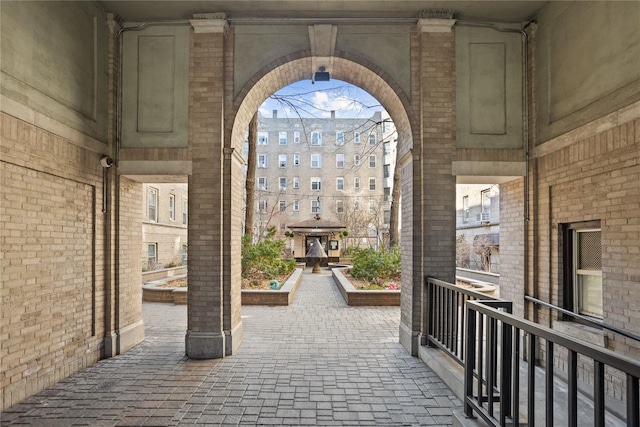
[{"left": 351, "top": 246, "right": 400, "bottom": 283}]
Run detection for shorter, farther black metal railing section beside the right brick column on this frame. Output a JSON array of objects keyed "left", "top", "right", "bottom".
[{"left": 421, "top": 277, "right": 511, "bottom": 365}]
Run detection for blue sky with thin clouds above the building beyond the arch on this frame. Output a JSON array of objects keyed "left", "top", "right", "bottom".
[{"left": 260, "top": 79, "right": 383, "bottom": 118}]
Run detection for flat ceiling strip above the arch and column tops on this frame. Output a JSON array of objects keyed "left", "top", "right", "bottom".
[{"left": 99, "top": 0, "right": 548, "bottom": 23}]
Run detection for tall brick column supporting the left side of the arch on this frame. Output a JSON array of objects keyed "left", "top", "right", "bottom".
[{"left": 185, "top": 15, "right": 227, "bottom": 359}]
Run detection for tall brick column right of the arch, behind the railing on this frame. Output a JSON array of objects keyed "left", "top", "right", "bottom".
[{"left": 400, "top": 19, "right": 456, "bottom": 355}]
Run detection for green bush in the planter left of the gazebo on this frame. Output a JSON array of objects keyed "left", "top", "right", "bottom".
[{"left": 242, "top": 233, "right": 296, "bottom": 279}]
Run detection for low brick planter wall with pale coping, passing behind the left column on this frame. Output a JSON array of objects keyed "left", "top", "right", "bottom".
[{"left": 142, "top": 268, "right": 303, "bottom": 305}]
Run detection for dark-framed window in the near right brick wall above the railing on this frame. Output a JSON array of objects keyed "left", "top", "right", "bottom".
[{"left": 564, "top": 221, "right": 602, "bottom": 319}]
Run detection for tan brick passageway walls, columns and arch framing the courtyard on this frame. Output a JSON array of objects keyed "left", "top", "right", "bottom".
[{"left": 0, "top": 0, "right": 640, "bottom": 409}]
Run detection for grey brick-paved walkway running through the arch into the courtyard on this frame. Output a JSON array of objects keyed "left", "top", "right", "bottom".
[{"left": 1, "top": 270, "right": 461, "bottom": 427}]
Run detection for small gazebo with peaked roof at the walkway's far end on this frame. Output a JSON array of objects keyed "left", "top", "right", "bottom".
[{"left": 287, "top": 216, "right": 346, "bottom": 262}]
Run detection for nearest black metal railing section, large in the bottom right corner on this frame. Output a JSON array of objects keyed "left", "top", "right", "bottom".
[{"left": 464, "top": 300, "right": 640, "bottom": 427}]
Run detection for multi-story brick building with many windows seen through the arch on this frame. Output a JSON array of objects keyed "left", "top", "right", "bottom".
[{"left": 251, "top": 110, "right": 394, "bottom": 252}]
